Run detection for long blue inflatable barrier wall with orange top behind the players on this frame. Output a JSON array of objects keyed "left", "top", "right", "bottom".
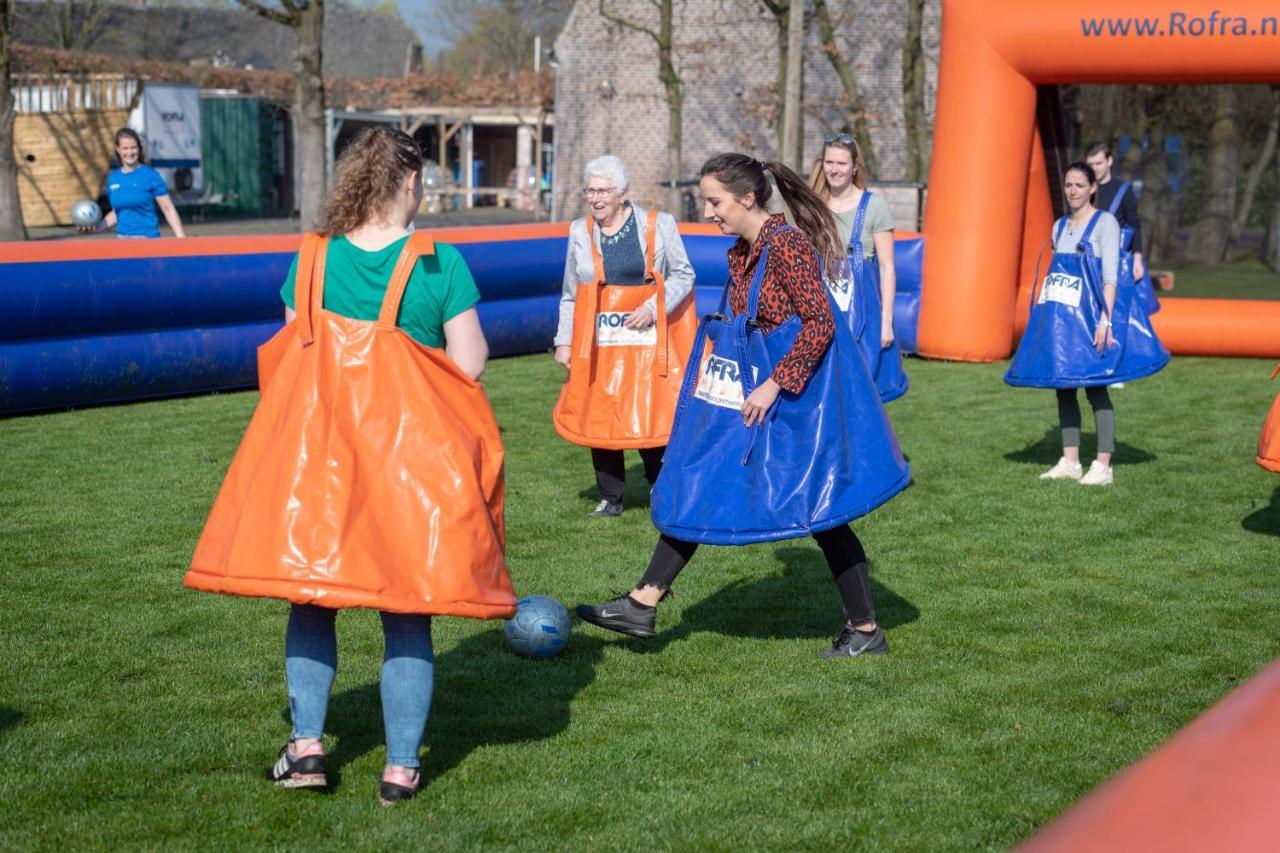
[{"left": 0, "top": 223, "right": 922, "bottom": 414}]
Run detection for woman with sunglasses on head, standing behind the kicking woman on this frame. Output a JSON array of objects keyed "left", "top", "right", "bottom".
[{"left": 809, "top": 133, "right": 906, "bottom": 402}]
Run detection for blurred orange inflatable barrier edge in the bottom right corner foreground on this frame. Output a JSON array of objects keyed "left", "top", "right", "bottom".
[{"left": 1020, "top": 650, "right": 1280, "bottom": 853}]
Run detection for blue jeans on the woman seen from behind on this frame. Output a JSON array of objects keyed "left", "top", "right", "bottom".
[{"left": 284, "top": 605, "right": 435, "bottom": 767}]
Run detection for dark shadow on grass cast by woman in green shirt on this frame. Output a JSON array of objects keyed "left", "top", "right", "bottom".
[{"left": 317, "top": 630, "right": 604, "bottom": 789}]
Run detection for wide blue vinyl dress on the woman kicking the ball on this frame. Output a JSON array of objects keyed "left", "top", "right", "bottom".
[{"left": 652, "top": 227, "right": 910, "bottom": 544}]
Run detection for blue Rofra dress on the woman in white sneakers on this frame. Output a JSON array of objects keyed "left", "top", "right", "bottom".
[{"left": 1005, "top": 211, "right": 1169, "bottom": 388}]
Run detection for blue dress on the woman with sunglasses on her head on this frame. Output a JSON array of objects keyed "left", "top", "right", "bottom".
[{"left": 827, "top": 191, "right": 908, "bottom": 402}]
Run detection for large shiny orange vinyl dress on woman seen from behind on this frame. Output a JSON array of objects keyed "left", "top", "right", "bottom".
[{"left": 184, "top": 232, "right": 516, "bottom": 619}]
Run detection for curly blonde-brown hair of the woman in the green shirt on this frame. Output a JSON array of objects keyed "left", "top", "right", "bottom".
[{"left": 316, "top": 127, "right": 422, "bottom": 237}]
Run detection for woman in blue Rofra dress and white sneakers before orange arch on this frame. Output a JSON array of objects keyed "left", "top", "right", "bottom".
[{"left": 1005, "top": 163, "right": 1169, "bottom": 485}]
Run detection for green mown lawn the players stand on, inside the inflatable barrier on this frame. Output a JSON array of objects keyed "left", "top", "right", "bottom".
[{"left": 0, "top": 356, "right": 1280, "bottom": 850}]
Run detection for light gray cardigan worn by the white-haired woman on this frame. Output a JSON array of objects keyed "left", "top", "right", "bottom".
[{"left": 556, "top": 205, "right": 694, "bottom": 347}]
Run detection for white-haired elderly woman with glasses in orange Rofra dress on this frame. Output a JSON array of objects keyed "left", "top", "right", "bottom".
[{"left": 553, "top": 155, "right": 696, "bottom": 517}]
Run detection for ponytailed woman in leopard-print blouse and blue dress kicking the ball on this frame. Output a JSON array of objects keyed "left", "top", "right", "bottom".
[{"left": 577, "top": 154, "right": 910, "bottom": 657}]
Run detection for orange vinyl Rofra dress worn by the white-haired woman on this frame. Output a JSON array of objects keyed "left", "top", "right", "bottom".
[{"left": 552, "top": 210, "right": 698, "bottom": 450}]
